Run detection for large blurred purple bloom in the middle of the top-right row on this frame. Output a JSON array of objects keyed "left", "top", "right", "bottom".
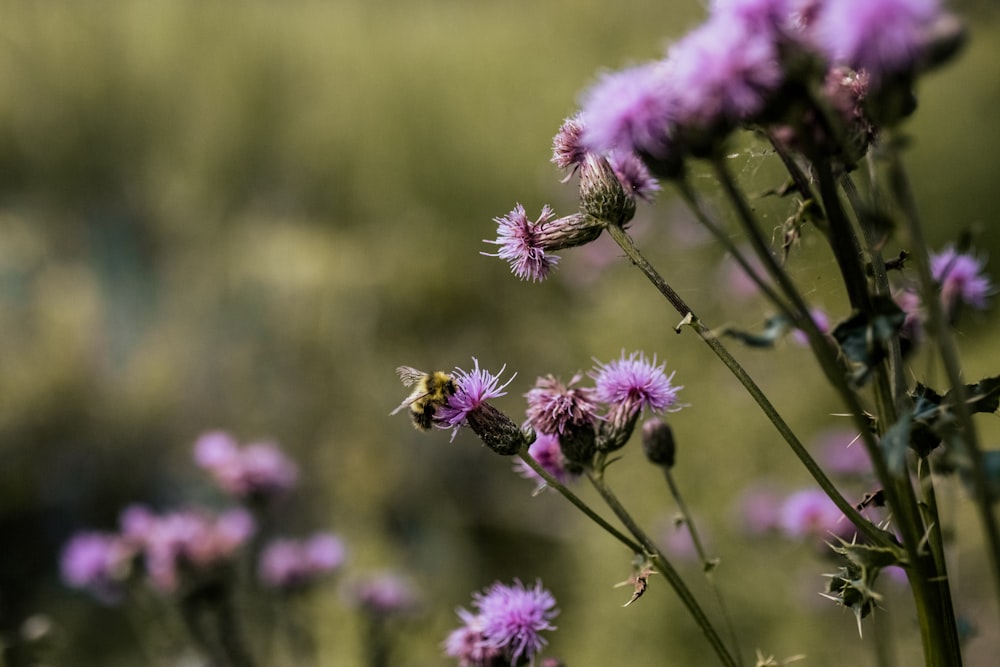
[{"left": 668, "top": 14, "right": 785, "bottom": 133}]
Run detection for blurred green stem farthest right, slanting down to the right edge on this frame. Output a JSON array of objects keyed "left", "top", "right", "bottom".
[{"left": 889, "top": 144, "right": 1000, "bottom": 620}]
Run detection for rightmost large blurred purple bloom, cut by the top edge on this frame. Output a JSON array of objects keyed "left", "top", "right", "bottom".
[{"left": 811, "top": 0, "right": 946, "bottom": 84}]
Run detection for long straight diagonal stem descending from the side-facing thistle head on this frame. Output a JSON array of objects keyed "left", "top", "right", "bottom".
[{"left": 607, "top": 225, "right": 891, "bottom": 546}]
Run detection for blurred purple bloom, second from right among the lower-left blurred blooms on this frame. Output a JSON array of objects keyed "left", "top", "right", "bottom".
[{"left": 258, "top": 533, "right": 347, "bottom": 590}]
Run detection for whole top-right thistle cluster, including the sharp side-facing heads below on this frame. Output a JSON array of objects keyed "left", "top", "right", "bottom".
[{"left": 484, "top": 0, "right": 963, "bottom": 281}]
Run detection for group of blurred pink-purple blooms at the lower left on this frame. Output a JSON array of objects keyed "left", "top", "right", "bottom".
[{"left": 61, "top": 431, "right": 346, "bottom": 602}]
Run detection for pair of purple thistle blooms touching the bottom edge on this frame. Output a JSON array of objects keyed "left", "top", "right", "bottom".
[{"left": 444, "top": 580, "right": 559, "bottom": 667}]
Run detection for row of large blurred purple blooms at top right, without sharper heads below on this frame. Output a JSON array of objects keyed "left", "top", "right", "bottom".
[{"left": 577, "top": 0, "right": 961, "bottom": 162}]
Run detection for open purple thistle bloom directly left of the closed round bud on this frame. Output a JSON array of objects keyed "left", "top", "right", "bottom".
[{"left": 590, "top": 350, "right": 683, "bottom": 413}]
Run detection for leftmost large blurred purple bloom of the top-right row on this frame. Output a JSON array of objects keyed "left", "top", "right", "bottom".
[{"left": 582, "top": 61, "right": 674, "bottom": 159}]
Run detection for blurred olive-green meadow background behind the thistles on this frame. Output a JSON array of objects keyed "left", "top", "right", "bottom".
[{"left": 0, "top": 0, "right": 1000, "bottom": 667}]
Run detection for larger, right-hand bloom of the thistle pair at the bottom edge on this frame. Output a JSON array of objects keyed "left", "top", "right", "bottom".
[{"left": 473, "top": 579, "right": 559, "bottom": 665}]
